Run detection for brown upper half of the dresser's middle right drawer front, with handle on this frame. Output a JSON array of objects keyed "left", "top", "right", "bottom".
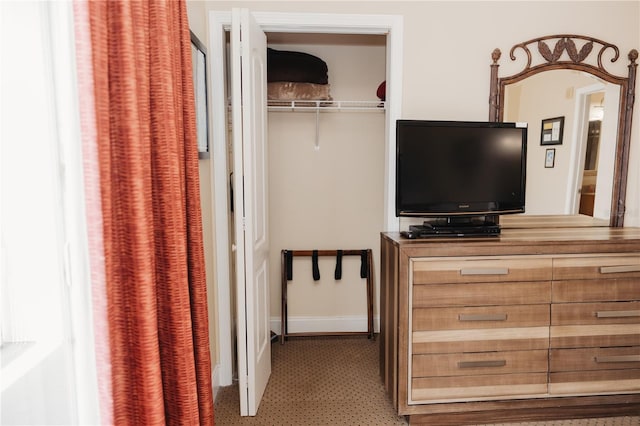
[{"left": 551, "top": 302, "right": 640, "bottom": 326}]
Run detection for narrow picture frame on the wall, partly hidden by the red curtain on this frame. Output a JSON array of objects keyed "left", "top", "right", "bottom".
[{"left": 189, "top": 31, "right": 209, "bottom": 159}]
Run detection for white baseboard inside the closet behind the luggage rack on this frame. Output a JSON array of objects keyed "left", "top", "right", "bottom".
[{"left": 270, "top": 315, "right": 380, "bottom": 335}]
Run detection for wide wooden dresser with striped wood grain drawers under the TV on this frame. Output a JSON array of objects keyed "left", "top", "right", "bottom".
[{"left": 380, "top": 227, "right": 640, "bottom": 425}]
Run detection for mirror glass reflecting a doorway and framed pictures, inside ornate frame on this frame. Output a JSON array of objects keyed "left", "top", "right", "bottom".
[{"left": 503, "top": 69, "right": 620, "bottom": 221}]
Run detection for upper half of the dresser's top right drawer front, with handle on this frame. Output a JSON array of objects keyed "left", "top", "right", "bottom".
[{"left": 553, "top": 254, "right": 640, "bottom": 280}]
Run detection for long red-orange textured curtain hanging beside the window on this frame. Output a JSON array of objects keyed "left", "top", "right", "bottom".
[{"left": 74, "top": 0, "right": 213, "bottom": 425}]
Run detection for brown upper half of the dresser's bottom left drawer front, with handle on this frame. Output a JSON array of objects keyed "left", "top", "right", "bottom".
[{"left": 412, "top": 350, "right": 548, "bottom": 378}]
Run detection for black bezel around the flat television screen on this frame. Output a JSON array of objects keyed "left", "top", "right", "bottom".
[{"left": 395, "top": 119, "right": 528, "bottom": 219}]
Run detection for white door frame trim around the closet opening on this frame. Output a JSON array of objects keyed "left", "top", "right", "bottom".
[{"left": 208, "top": 10, "right": 403, "bottom": 386}]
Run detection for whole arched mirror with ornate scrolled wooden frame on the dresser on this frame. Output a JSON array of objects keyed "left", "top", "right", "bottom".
[{"left": 489, "top": 34, "right": 638, "bottom": 227}]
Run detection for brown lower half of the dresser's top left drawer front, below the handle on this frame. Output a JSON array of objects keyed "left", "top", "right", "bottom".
[{"left": 413, "top": 281, "right": 551, "bottom": 307}]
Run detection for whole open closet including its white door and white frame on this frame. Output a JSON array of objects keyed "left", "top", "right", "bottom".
[{"left": 209, "top": 10, "right": 402, "bottom": 415}]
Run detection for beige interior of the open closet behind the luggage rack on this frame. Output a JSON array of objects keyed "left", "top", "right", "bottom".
[{"left": 267, "top": 33, "right": 386, "bottom": 332}]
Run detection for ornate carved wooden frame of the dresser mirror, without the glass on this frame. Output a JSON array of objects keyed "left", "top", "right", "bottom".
[{"left": 489, "top": 34, "right": 638, "bottom": 227}]
